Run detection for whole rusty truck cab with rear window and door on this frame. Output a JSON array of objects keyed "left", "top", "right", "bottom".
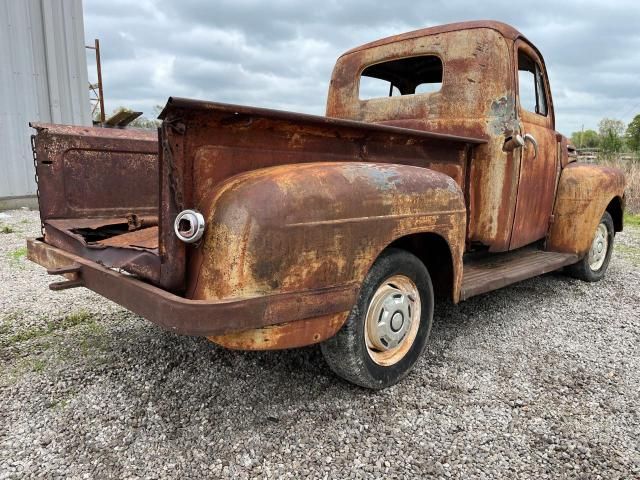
[{"left": 327, "top": 22, "right": 584, "bottom": 252}]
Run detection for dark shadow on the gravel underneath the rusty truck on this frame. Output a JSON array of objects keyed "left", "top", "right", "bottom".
[{"left": 84, "top": 274, "right": 571, "bottom": 428}]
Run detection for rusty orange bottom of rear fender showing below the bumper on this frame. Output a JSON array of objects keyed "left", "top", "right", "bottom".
[{"left": 208, "top": 312, "right": 349, "bottom": 350}]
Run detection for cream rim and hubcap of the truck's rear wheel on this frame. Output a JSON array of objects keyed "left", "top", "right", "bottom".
[{"left": 365, "top": 275, "right": 421, "bottom": 365}]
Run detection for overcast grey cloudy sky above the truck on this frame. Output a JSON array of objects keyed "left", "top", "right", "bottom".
[{"left": 84, "top": 0, "right": 640, "bottom": 135}]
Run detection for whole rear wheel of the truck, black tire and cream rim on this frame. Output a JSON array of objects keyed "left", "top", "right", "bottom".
[{"left": 321, "top": 248, "right": 433, "bottom": 389}]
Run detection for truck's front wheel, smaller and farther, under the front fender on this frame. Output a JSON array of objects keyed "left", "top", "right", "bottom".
[{"left": 566, "top": 212, "right": 615, "bottom": 282}]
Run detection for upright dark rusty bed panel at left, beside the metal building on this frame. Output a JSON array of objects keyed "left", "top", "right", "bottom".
[{"left": 31, "top": 123, "right": 158, "bottom": 221}]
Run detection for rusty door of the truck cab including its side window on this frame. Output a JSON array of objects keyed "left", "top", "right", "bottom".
[{"left": 509, "top": 40, "right": 557, "bottom": 250}]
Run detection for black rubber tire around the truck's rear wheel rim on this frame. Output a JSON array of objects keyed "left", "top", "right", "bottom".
[{"left": 320, "top": 248, "right": 434, "bottom": 389}]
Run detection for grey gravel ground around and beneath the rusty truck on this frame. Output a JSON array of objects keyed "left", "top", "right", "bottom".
[{"left": 0, "top": 211, "right": 640, "bottom": 479}]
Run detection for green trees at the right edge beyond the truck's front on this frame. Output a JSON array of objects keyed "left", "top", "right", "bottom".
[{"left": 571, "top": 114, "right": 640, "bottom": 153}]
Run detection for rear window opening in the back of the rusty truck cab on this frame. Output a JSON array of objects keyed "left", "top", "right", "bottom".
[{"left": 359, "top": 55, "right": 443, "bottom": 100}]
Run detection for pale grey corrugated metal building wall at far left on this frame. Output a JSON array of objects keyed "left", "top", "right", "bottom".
[{"left": 0, "top": 0, "right": 91, "bottom": 199}]
